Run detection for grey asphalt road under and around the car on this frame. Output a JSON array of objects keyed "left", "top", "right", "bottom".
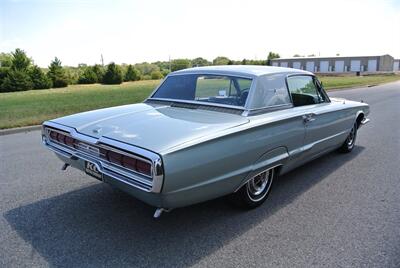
[{"left": 0, "top": 82, "right": 400, "bottom": 267}]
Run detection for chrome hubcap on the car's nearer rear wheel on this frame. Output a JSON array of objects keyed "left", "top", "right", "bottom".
[{"left": 246, "top": 169, "right": 274, "bottom": 202}]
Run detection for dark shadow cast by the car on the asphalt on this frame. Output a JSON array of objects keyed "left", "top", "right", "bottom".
[{"left": 4, "top": 146, "right": 364, "bottom": 267}]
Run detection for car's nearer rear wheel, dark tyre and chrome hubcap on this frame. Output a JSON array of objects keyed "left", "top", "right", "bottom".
[{"left": 233, "top": 168, "right": 277, "bottom": 208}]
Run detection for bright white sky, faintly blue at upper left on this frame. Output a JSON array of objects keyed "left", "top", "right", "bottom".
[{"left": 0, "top": 0, "right": 400, "bottom": 67}]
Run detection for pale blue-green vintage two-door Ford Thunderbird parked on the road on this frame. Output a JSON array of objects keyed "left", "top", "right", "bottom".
[{"left": 42, "top": 66, "right": 369, "bottom": 217}]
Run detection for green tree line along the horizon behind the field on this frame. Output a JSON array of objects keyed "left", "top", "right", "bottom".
[{"left": 0, "top": 48, "right": 280, "bottom": 92}]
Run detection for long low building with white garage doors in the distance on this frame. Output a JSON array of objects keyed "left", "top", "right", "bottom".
[{"left": 271, "top": 55, "right": 400, "bottom": 73}]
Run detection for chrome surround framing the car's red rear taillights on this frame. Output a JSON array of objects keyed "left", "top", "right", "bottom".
[{"left": 42, "top": 121, "right": 164, "bottom": 193}]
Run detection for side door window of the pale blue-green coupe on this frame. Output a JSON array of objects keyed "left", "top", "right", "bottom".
[{"left": 287, "top": 75, "right": 325, "bottom": 106}]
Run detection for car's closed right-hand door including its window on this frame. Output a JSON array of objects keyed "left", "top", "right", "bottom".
[{"left": 287, "top": 75, "right": 346, "bottom": 160}]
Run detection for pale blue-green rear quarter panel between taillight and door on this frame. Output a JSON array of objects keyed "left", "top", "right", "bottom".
[{"left": 158, "top": 111, "right": 304, "bottom": 207}]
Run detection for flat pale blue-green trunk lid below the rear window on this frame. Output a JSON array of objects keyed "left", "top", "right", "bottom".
[{"left": 51, "top": 103, "right": 248, "bottom": 152}]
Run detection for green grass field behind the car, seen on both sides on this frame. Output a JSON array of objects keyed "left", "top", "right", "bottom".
[{"left": 0, "top": 75, "right": 400, "bottom": 129}]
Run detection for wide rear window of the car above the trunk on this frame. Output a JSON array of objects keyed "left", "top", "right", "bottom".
[{"left": 152, "top": 74, "right": 252, "bottom": 107}]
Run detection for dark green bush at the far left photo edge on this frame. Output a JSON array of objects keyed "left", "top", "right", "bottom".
[{"left": 0, "top": 69, "right": 32, "bottom": 92}]
